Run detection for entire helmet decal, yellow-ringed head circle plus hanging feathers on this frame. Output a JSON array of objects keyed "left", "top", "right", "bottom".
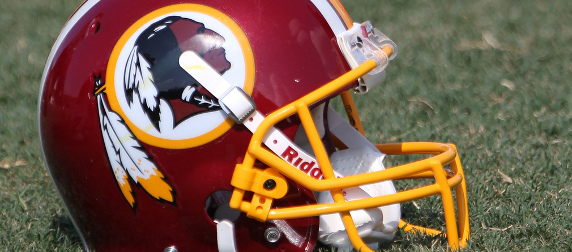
[{"left": 95, "top": 4, "right": 254, "bottom": 209}]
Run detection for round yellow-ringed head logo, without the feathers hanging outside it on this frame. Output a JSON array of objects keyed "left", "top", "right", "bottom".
[{"left": 105, "top": 4, "right": 254, "bottom": 149}]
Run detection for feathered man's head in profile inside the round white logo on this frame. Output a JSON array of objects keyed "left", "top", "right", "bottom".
[{"left": 124, "top": 17, "right": 231, "bottom": 132}]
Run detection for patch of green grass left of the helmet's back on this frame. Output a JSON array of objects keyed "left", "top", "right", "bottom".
[{"left": 0, "top": 0, "right": 86, "bottom": 251}]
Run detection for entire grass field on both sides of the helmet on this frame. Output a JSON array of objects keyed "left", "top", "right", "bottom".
[{"left": 0, "top": 0, "right": 572, "bottom": 251}]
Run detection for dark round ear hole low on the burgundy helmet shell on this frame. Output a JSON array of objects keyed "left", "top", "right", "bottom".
[{"left": 205, "top": 190, "right": 241, "bottom": 223}]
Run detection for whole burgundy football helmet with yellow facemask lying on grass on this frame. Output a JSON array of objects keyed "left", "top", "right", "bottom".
[{"left": 38, "top": 0, "right": 469, "bottom": 251}]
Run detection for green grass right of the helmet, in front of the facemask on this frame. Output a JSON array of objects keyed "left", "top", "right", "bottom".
[{"left": 338, "top": 1, "right": 572, "bottom": 251}]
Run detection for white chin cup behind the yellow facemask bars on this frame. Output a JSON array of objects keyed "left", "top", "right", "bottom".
[{"left": 318, "top": 147, "right": 401, "bottom": 249}]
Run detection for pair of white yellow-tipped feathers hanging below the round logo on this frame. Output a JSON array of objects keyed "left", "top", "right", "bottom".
[{"left": 97, "top": 93, "right": 174, "bottom": 207}]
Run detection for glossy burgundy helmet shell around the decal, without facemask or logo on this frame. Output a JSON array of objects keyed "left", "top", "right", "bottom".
[{"left": 39, "top": 0, "right": 349, "bottom": 251}]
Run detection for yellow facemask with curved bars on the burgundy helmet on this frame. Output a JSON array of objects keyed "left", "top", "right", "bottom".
[{"left": 229, "top": 60, "right": 469, "bottom": 251}]
